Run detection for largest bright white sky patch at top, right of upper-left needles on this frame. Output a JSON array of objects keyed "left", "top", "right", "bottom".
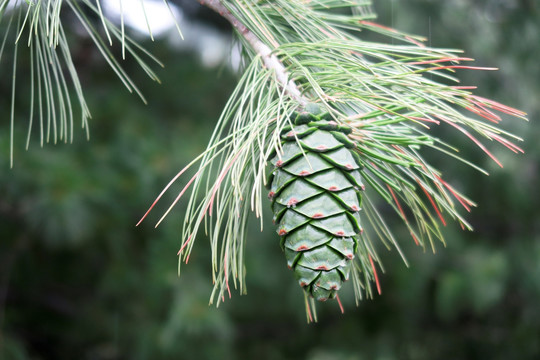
[{"left": 101, "top": 0, "right": 183, "bottom": 37}]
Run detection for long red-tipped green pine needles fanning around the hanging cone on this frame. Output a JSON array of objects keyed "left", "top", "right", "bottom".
[{"left": 137, "top": 0, "right": 525, "bottom": 320}]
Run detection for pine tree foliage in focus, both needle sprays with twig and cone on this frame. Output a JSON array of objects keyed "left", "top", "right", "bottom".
[{"left": 0, "top": 0, "right": 525, "bottom": 320}]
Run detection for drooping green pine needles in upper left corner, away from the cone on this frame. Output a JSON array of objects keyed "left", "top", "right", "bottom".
[{"left": 0, "top": 0, "right": 171, "bottom": 166}]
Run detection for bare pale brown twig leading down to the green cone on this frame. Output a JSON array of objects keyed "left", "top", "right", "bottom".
[{"left": 199, "top": 0, "right": 308, "bottom": 106}]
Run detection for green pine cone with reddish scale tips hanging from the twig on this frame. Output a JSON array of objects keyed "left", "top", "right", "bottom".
[{"left": 269, "top": 107, "right": 364, "bottom": 301}]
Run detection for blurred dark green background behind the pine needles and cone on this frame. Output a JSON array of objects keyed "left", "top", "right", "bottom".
[{"left": 0, "top": 0, "right": 540, "bottom": 360}]
